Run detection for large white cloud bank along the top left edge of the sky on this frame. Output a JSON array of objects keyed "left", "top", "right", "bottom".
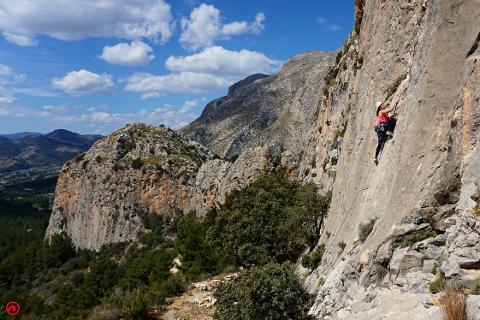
[{"left": 0, "top": 0, "right": 174, "bottom": 46}]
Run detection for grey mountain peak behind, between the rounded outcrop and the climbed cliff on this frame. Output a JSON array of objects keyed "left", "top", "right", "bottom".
[{"left": 181, "top": 52, "right": 334, "bottom": 160}]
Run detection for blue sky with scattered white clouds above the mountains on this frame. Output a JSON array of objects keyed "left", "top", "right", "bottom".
[{"left": 0, "top": 0, "right": 353, "bottom": 134}]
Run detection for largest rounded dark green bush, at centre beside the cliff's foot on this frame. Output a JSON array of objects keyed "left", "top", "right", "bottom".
[{"left": 205, "top": 170, "right": 330, "bottom": 266}]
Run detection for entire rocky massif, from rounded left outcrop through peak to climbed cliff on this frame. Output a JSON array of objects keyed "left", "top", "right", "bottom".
[{"left": 47, "top": 0, "right": 480, "bottom": 320}]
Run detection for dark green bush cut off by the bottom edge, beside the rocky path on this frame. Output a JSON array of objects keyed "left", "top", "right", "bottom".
[{"left": 214, "top": 264, "right": 313, "bottom": 320}]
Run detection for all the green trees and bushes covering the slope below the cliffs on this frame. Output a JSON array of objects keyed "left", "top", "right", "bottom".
[{"left": 0, "top": 170, "right": 330, "bottom": 319}]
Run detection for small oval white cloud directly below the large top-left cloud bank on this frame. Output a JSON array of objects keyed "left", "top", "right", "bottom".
[{"left": 99, "top": 41, "right": 155, "bottom": 67}]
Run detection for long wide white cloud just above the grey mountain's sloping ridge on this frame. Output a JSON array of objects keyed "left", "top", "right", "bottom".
[{"left": 124, "top": 46, "right": 281, "bottom": 98}]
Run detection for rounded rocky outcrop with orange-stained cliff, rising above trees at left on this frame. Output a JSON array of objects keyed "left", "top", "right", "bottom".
[{"left": 46, "top": 125, "right": 212, "bottom": 250}]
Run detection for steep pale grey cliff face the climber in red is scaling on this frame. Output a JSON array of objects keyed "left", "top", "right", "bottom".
[{"left": 299, "top": 0, "right": 480, "bottom": 319}]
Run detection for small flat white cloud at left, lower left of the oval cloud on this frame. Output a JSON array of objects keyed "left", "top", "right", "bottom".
[{"left": 52, "top": 70, "right": 114, "bottom": 96}]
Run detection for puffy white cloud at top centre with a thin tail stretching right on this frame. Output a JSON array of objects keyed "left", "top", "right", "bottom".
[{"left": 180, "top": 3, "right": 265, "bottom": 51}]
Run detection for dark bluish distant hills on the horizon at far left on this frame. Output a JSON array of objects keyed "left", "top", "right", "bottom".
[{"left": 0, "top": 129, "right": 102, "bottom": 176}]
